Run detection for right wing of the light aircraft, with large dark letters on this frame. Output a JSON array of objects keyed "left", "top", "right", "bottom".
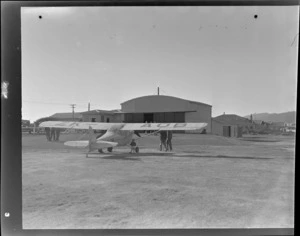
[{"left": 121, "top": 123, "right": 207, "bottom": 130}]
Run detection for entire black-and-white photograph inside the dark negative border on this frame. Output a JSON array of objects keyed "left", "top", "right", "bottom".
[{"left": 21, "top": 6, "right": 299, "bottom": 229}]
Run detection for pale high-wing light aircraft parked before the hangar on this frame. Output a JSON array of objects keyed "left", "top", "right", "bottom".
[{"left": 39, "top": 121, "right": 207, "bottom": 157}]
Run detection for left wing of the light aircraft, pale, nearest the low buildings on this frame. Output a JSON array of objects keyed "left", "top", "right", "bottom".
[{"left": 39, "top": 121, "right": 118, "bottom": 130}]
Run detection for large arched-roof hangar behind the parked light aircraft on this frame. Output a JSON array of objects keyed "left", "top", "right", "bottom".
[{"left": 121, "top": 95, "right": 212, "bottom": 132}]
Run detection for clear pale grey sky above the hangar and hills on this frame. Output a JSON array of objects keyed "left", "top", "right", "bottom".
[{"left": 21, "top": 6, "right": 299, "bottom": 121}]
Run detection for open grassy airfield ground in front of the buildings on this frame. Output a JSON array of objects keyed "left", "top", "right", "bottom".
[{"left": 22, "top": 134, "right": 295, "bottom": 229}]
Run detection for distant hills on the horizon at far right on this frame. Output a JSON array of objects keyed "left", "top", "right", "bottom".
[{"left": 245, "top": 111, "right": 296, "bottom": 123}]
